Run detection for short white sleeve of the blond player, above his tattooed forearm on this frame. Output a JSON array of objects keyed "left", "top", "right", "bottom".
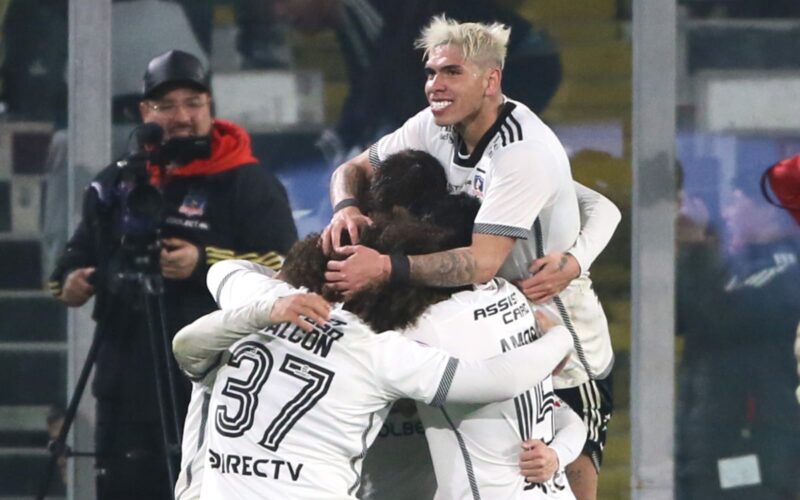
[{"left": 473, "top": 142, "right": 556, "bottom": 239}]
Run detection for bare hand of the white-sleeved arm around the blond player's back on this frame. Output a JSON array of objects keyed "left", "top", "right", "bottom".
[{"left": 514, "top": 252, "right": 581, "bottom": 304}]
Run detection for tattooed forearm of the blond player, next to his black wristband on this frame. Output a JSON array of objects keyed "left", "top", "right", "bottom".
[{"left": 409, "top": 248, "right": 478, "bottom": 287}]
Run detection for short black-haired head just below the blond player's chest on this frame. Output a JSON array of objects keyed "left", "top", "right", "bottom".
[{"left": 369, "top": 149, "right": 447, "bottom": 217}]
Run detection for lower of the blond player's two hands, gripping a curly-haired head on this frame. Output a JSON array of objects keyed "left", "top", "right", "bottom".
[{"left": 325, "top": 245, "right": 392, "bottom": 298}]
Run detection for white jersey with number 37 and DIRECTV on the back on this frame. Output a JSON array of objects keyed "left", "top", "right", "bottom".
[{"left": 202, "top": 307, "right": 457, "bottom": 500}]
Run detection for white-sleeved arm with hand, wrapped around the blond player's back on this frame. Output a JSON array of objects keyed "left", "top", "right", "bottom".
[{"left": 515, "top": 182, "right": 622, "bottom": 302}]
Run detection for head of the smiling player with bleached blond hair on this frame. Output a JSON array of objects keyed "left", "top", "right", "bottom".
[{"left": 415, "top": 15, "right": 511, "bottom": 126}]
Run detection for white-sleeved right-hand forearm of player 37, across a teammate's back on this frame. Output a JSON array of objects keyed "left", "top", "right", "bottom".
[{"left": 446, "top": 326, "right": 572, "bottom": 404}]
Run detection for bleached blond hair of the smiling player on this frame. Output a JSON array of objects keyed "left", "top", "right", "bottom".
[{"left": 414, "top": 14, "right": 511, "bottom": 69}]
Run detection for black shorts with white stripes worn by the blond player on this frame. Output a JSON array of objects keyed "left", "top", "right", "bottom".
[{"left": 556, "top": 374, "right": 614, "bottom": 474}]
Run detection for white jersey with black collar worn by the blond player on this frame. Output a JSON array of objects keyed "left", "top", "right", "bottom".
[{"left": 369, "top": 98, "right": 618, "bottom": 387}]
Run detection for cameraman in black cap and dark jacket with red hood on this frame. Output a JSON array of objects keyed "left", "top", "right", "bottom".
[{"left": 50, "top": 50, "right": 297, "bottom": 499}]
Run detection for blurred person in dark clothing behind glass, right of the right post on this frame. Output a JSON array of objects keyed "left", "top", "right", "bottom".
[{"left": 676, "top": 165, "right": 800, "bottom": 500}]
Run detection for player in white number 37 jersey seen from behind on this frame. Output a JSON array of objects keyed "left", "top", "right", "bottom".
[{"left": 174, "top": 213, "right": 570, "bottom": 499}]
